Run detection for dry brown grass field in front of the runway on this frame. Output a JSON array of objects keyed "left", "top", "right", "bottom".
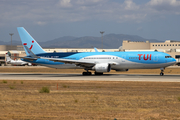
[{"left": 0, "top": 80, "right": 180, "bottom": 120}]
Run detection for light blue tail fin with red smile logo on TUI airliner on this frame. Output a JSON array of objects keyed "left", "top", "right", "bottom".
[{"left": 17, "top": 27, "right": 46, "bottom": 56}]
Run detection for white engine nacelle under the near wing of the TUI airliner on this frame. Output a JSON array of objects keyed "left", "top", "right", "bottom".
[{"left": 93, "top": 63, "right": 111, "bottom": 72}]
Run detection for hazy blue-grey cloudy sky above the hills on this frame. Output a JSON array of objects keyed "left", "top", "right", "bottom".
[{"left": 0, "top": 0, "right": 180, "bottom": 42}]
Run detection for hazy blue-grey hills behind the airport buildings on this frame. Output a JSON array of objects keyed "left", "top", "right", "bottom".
[{"left": 1, "top": 34, "right": 162, "bottom": 49}]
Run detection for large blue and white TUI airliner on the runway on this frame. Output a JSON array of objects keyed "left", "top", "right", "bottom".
[{"left": 17, "top": 27, "right": 176, "bottom": 76}]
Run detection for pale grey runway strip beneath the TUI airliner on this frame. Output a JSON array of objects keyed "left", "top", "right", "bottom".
[{"left": 0, "top": 73, "right": 180, "bottom": 82}]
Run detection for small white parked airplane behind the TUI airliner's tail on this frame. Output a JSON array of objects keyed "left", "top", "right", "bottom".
[{"left": 6, "top": 53, "right": 32, "bottom": 66}]
